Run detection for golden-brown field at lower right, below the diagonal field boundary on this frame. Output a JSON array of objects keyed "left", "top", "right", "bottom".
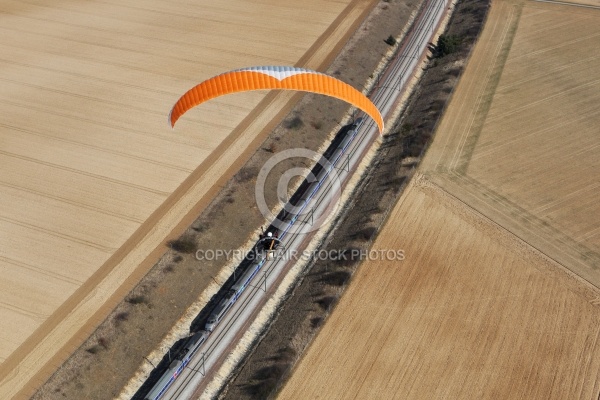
[{"left": 279, "top": 176, "right": 600, "bottom": 399}]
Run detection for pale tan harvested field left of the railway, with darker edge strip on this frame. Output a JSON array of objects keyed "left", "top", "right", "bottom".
[{"left": 0, "top": 0, "right": 371, "bottom": 398}]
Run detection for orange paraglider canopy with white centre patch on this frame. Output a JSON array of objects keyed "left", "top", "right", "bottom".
[{"left": 169, "top": 66, "right": 383, "bottom": 133}]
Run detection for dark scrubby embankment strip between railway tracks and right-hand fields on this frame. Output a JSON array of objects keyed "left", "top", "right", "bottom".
[{"left": 221, "top": 0, "right": 489, "bottom": 399}]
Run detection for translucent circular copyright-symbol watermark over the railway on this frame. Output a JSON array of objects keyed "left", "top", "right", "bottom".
[{"left": 254, "top": 148, "right": 342, "bottom": 234}]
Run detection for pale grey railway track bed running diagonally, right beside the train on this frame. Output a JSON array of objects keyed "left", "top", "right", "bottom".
[{"left": 141, "top": 0, "right": 450, "bottom": 400}]
